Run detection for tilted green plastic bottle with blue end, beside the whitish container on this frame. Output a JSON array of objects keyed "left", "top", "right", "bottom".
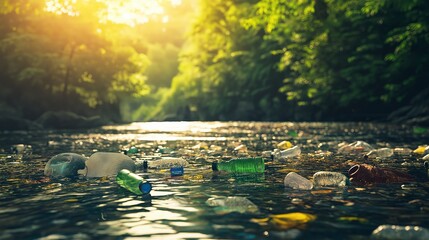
[{"left": 116, "top": 169, "right": 152, "bottom": 195}]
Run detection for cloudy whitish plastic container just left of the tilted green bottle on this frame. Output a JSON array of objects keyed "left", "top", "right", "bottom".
[{"left": 81, "top": 152, "right": 136, "bottom": 177}]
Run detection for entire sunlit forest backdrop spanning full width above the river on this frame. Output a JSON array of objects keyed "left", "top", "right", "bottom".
[{"left": 0, "top": 0, "right": 429, "bottom": 124}]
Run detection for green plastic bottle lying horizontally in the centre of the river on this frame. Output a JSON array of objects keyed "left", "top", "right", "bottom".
[{"left": 212, "top": 157, "right": 265, "bottom": 173}]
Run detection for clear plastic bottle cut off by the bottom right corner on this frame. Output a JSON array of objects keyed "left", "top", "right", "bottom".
[{"left": 371, "top": 225, "right": 429, "bottom": 240}]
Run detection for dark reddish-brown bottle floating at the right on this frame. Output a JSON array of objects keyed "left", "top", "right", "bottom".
[{"left": 348, "top": 164, "right": 414, "bottom": 185}]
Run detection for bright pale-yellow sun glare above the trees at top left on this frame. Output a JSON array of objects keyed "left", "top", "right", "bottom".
[{"left": 45, "top": 0, "right": 182, "bottom": 26}]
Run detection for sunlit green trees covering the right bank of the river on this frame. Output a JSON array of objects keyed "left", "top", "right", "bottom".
[{"left": 155, "top": 0, "right": 429, "bottom": 120}]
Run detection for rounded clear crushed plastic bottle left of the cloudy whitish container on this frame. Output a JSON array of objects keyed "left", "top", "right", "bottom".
[{"left": 44, "top": 153, "right": 87, "bottom": 177}]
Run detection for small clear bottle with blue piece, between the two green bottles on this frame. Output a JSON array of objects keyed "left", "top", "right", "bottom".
[{"left": 143, "top": 157, "right": 189, "bottom": 176}]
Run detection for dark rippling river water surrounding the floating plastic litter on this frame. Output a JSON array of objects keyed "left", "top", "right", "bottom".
[{"left": 0, "top": 122, "right": 429, "bottom": 239}]
